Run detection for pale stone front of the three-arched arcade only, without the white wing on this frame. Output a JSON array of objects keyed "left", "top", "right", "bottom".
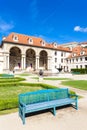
[{"left": 3, "top": 43, "right": 51, "bottom": 70}]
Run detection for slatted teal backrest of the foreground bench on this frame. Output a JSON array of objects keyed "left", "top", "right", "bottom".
[{"left": 19, "top": 89, "right": 68, "bottom": 104}]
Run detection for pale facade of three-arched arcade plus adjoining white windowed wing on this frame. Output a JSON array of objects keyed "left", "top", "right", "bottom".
[{"left": 2, "top": 43, "right": 70, "bottom": 72}]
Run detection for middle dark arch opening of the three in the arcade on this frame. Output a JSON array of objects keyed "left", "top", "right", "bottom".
[{"left": 26, "top": 49, "right": 36, "bottom": 70}]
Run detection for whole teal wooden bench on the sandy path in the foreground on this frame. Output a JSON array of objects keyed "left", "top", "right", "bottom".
[{"left": 19, "top": 88, "right": 78, "bottom": 124}]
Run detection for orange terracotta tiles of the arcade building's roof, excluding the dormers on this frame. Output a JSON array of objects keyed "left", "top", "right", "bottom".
[{"left": 3, "top": 32, "right": 71, "bottom": 52}]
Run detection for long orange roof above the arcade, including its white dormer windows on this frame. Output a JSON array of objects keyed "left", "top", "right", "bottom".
[{"left": 3, "top": 32, "right": 71, "bottom": 52}]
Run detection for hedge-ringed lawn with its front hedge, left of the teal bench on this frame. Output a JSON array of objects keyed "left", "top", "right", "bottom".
[{"left": 0, "top": 86, "right": 43, "bottom": 110}]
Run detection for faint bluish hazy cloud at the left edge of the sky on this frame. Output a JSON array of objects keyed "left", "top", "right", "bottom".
[{"left": 0, "top": 18, "right": 14, "bottom": 33}]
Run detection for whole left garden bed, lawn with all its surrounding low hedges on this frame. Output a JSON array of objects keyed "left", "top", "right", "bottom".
[{"left": 0, "top": 78, "right": 56, "bottom": 113}]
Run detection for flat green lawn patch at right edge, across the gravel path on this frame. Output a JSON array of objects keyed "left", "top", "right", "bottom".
[{"left": 62, "top": 80, "right": 87, "bottom": 90}]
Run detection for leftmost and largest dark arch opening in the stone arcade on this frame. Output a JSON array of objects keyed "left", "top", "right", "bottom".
[{"left": 9, "top": 47, "right": 21, "bottom": 70}]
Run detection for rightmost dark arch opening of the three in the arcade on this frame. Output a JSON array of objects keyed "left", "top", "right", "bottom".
[{"left": 39, "top": 50, "right": 48, "bottom": 70}]
